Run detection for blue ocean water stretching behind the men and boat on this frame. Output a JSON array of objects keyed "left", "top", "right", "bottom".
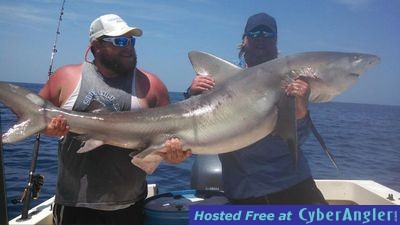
[{"left": 0, "top": 83, "right": 400, "bottom": 219}]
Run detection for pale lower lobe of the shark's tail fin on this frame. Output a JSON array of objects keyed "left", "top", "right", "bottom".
[{"left": 2, "top": 119, "right": 47, "bottom": 143}]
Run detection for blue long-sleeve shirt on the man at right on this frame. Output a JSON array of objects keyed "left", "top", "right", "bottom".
[{"left": 219, "top": 114, "right": 311, "bottom": 199}]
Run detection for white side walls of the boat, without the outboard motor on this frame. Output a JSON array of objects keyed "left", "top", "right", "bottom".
[{"left": 9, "top": 179, "right": 400, "bottom": 225}]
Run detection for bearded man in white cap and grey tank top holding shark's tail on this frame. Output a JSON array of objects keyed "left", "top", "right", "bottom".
[{"left": 40, "top": 14, "right": 190, "bottom": 224}]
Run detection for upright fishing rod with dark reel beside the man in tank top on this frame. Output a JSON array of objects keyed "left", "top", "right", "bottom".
[{"left": 13, "top": 0, "right": 66, "bottom": 220}]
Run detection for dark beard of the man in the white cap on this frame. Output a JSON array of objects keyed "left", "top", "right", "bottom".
[{"left": 97, "top": 51, "right": 137, "bottom": 76}]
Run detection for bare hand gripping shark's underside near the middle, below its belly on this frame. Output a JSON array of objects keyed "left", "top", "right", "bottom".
[{"left": 159, "top": 138, "right": 192, "bottom": 164}]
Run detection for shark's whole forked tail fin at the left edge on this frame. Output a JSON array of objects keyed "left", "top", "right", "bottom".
[{"left": 0, "top": 82, "right": 54, "bottom": 143}]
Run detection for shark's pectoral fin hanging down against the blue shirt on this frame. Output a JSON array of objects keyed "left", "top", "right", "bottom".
[{"left": 275, "top": 94, "right": 298, "bottom": 167}]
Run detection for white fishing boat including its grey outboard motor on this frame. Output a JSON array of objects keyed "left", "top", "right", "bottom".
[{"left": 5, "top": 155, "right": 400, "bottom": 225}]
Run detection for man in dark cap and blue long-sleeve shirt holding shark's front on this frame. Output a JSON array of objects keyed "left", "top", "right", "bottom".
[{"left": 185, "top": 13, "right": 327, "bottom": 205}]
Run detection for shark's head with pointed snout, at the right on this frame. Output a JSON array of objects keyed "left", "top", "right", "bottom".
[{"left": 274, "top": 52, "right": 380, "bottom": 102}]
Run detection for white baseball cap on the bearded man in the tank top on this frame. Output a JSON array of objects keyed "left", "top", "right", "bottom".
[{"left": 89, "top": 14, "right": 143, "bottom": 42}]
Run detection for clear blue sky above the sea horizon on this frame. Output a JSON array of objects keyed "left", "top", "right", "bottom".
[{"left": 0, "top": 0, "right": 400, "bottom": 105}]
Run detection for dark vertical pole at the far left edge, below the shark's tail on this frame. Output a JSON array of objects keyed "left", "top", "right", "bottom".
[{"left": 0, "top": 112, "right": 8, "bottom": 225}]
